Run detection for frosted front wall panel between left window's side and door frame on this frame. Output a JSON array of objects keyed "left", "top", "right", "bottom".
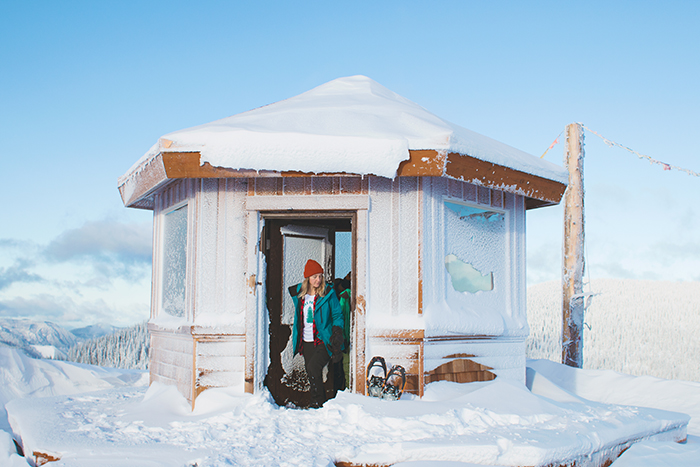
[{"left": 192, "top": 178, "right": 249, "bottom": 397}]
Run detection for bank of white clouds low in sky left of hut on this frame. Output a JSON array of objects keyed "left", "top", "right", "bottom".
[{"left": 0, "top": 220, "right": 151, "bottom": 327}]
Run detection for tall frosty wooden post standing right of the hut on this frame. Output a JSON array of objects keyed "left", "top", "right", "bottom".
[{"left": 561, "top": 123, "right": 584, "bottom": 368}]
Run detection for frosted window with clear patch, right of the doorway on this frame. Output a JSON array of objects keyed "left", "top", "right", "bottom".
[{"left": 445, "top": 201, "right": 506, "bottom": 298}]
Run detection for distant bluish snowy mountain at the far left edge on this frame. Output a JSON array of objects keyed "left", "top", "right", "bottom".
[{"left": 0, "top": 318, "right": 78, "bottom": 358}]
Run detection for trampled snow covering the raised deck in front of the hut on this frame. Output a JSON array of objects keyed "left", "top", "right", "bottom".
[{"left": 8, "top": 380, "right": 687, "bottom": 467}]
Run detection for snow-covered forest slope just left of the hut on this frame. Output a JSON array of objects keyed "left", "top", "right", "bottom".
[{"left": 66, "top": 322, "right": 150, "bottom": 370}]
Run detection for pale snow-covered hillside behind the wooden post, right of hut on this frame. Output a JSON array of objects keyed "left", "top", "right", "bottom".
[{"left": 527, "top": 279, "right": 700, "bottom": 381}]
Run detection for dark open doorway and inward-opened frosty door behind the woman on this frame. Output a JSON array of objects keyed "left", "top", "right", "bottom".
[{"left": 264, "top": 218, "right": 350, "bottom": 407}]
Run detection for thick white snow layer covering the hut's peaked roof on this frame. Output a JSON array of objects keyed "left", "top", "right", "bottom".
[{"left": 119, "top": 75, "right": 568, "bottom": 207}]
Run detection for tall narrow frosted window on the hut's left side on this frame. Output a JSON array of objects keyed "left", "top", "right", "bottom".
[{"left": 162, "top": 206, "right": 187, "bottom": 316}]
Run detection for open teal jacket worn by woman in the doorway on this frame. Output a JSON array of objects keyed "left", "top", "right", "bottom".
[{"left": 289, "top": 284, "right": 344, "bottom": 355}]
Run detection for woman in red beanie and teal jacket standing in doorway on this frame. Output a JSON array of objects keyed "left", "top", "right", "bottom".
[{"left": 289, "top": 259, "right": 343, "bottom": 408}]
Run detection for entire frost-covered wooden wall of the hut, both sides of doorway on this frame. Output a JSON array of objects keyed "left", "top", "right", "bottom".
[{"left": 149, "top": 177, "right": 527, "bottom": 400}]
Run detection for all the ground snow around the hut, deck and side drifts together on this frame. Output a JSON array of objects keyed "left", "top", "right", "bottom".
[{"left": 0, "top": 348, "right": 700, "bottom": 467}]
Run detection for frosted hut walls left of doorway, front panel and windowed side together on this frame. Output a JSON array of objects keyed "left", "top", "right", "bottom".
[{"left": 149, "top": 179, "right": 248, "bottom": 400}]
